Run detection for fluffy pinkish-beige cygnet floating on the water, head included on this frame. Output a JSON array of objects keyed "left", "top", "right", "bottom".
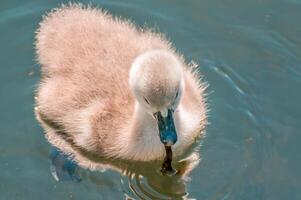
[{"left": 36, "top": 5, "right": 207, "bottom": 161}]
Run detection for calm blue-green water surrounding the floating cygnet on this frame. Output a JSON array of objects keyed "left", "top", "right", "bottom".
[{"left": 0, "top": 0, "right": 301, "bottom": 200}]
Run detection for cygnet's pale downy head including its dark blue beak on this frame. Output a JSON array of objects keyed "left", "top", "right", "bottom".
[{"left": 129, "top": 50, "right": 184, "bottom": 146}]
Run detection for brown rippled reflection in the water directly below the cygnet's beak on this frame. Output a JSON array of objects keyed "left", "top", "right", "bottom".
[{"left": 119, "top": 153, "right": 199, "bottom": 199}]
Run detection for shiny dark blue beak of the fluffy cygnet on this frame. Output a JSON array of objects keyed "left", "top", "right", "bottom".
[{"left": 155, "top": 110, "right": 178, "bottom": 146}]
